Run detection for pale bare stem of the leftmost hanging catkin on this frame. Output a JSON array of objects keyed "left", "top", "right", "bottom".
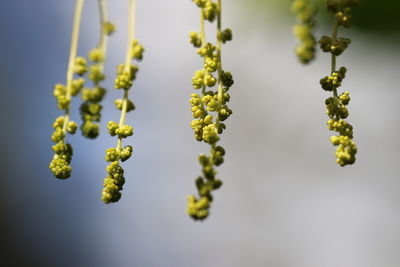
[{"left": 63, "top": 0, "right": 85, "bottom": 133}]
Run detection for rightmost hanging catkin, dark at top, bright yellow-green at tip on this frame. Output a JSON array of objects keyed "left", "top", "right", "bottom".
[{"left": 319, "top": 0, "right": 358, "bottom": 167}]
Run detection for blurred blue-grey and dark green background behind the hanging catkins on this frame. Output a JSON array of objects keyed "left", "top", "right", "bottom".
[{"left": 0, "top": 0, "right": 400, "bottom": 267}]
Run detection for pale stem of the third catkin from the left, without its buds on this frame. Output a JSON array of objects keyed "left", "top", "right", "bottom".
[{"left": 117, "top": 0, "right": 136, "bottom": 152}]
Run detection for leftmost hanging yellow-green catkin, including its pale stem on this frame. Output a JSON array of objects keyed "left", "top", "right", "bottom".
[{"left": 49, "top": 0, "right": 87, "bottom": 179}]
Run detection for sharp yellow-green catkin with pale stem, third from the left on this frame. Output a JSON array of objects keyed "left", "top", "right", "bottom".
[{"left": 101, "top": 0, "right": 144, "bottom": 204}]
